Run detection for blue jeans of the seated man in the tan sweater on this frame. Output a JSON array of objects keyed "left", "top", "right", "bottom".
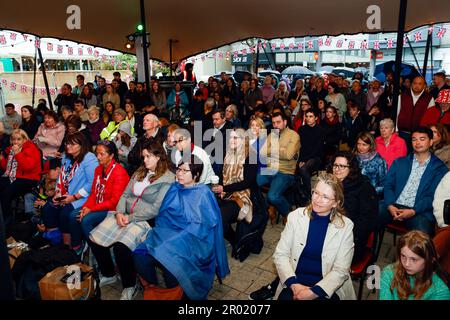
[{"left": 256, "top": 172, "right": 295, "bottom": 216}]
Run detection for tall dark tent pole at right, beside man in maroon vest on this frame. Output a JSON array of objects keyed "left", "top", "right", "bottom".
[{"left": 392, "top": 0, "right": 408, "bottom": 124}]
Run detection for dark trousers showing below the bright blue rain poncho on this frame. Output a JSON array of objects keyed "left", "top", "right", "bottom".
[{"left": 133, "top": 254, "right": 178, "bottom": 288}]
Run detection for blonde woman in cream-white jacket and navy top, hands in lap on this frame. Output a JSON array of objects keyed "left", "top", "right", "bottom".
[{"left": 273, "top": 174, "right": 356, "bottom": 300}]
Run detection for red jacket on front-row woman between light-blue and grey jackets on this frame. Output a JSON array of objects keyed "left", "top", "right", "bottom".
[{"left": 83, "top": 160, "right": 130, "bottom": 211}]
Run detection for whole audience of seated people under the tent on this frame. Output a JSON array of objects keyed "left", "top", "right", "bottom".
[{"left": 0, "top": 72, "right": 450, "bottom": 300}]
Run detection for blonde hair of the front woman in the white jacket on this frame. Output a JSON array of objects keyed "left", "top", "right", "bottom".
[{"left": 304, "top": 173, "right": 345, "bottom": 228}]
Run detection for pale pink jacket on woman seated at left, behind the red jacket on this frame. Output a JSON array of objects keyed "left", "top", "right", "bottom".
[{"left": 33, "top": 122, "right": 66, "bottom": 158}]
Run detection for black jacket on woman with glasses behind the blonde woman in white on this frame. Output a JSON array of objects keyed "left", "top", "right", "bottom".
[{"left": 343, "top": 175, "right": 378, "bottom": 261}]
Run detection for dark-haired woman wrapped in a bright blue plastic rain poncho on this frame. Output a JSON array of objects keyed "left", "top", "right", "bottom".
[{"left": 134, "top": 155, "right": 229, "bottom": 300}]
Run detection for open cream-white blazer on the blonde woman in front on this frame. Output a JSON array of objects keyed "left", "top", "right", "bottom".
[{"left": 273, "top": 208, "right": 356, "bottom": 300}]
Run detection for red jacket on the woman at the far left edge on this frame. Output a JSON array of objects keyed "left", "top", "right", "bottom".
[{"left": 0, "top": 140, "right": 42, "bottom": 181}]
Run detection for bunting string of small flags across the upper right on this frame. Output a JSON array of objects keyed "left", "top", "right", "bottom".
[{"left": 187, "top": 26, "right": 447, "bottom": 63}]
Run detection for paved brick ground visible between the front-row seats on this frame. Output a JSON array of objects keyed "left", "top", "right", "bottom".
[{"left": 102, "top": 218, "right": 394, "bottom": 300}]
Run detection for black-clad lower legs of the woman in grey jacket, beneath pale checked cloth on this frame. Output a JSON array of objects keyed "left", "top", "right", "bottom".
[{"left": 88, "top": 240, "right": 136, "bottom": 288}]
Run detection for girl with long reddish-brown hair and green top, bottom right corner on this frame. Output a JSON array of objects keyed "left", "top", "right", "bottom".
[{"left": 380, "top": 230, "right": 450, "bottom": 300}]
